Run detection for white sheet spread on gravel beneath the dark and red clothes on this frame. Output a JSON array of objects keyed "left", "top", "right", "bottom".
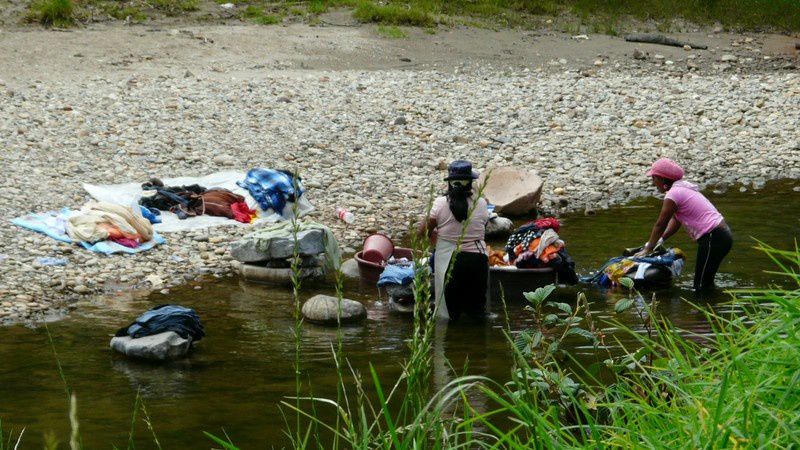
[{"left": 83, "top": 171, "right": 314, "bottom": 233}]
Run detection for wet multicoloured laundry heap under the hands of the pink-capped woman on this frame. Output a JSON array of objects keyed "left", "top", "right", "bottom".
[{"left": 580, "top": 246, "right": 686, "bottom": 289}]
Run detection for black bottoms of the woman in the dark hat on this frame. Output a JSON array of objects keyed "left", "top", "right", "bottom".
[{"left": 444, "top": 252, "right": 489, "bottom": 320}]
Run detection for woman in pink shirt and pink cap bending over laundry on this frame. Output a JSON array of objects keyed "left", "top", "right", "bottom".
[{"left": 639, "top": 158, "right": 733, "bottom": 291}]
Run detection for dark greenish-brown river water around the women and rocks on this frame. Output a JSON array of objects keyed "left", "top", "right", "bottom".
[{"left": 0, "top": 181, "right": 800, "bottom": 449}]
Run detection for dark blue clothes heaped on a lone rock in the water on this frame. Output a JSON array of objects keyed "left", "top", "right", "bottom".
[{"left": 115, "top": 305, "right": 206, "bottom": 342}]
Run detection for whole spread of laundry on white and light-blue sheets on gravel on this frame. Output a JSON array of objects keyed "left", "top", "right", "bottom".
[{"left": 12, "top": 169, "right": 313, "bottom": 255}]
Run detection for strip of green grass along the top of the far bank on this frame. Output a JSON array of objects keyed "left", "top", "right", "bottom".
[{"left": 26, "top": 0, "right": 800, "bottom": 30}]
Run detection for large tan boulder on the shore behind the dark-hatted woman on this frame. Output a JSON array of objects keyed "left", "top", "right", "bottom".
[{"left": 478, "top": 167, "right": 543, "bottom": 216}]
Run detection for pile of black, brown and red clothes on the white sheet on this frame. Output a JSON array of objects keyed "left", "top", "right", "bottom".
[{"left": 139, "top": 178, "right": 256, "bottom": 223}]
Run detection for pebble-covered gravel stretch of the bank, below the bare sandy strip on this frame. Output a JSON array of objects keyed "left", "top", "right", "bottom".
[{"left": 0, "top": 68, "right": 800, "bottom": 322}]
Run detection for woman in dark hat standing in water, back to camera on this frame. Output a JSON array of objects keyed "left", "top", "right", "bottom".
[{"left": 420, "top": 160, "right": 489, "bottom": 320}]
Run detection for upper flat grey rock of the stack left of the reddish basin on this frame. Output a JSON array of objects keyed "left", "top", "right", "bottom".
[{"left": 231, "top": 229, "right": 325, "bottom": 262}]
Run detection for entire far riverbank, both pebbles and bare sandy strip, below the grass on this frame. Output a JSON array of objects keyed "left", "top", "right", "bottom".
[{"left": 0, "top": 22, "right": 800, "bottom": 323}]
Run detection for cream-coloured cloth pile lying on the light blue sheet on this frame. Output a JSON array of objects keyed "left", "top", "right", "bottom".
[{"left": 69, "top": 202, "right": 154, "bottom": 248}]
